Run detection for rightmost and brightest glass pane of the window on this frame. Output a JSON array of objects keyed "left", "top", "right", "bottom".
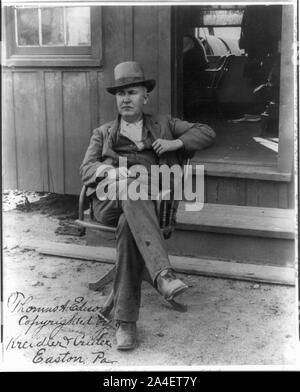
[{"left": 66, "top": 7, "right": 91, "bottom": 46}]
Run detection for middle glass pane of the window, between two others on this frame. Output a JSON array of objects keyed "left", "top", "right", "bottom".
[{"left": 41, "top": 8, "right": 64, "bottom": 45}]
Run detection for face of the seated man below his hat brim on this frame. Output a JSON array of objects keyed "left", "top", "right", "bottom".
[{"left": 116, "top": 86, "right": 148, "bottom": 122}]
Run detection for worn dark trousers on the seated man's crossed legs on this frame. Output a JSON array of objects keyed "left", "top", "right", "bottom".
[{"left": 93, "top": 181, "right": 171, "bottom": 322}]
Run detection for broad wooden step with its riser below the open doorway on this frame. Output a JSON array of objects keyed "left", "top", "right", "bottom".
[{"left": 86, "top": 203, "right": 295, "bottom": 267}]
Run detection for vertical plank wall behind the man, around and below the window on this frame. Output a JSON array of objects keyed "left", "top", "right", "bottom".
[{"left": 2, "top": 6, "right": 171, "bottom": 194}]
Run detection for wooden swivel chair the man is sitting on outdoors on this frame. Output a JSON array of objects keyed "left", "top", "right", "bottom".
[{"left": 76, "top": 158, "right": 190, "bottom": 317}]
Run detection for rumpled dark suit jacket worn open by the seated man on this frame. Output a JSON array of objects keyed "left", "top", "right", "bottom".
[{"left": 80, "top": 114, "right": 215, "bottom": 196}]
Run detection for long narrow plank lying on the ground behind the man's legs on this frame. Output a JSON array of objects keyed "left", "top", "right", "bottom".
[{"left": 22, "top": 241, "right": 296, "bottom": 286}]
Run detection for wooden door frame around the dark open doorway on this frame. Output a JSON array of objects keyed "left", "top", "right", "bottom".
[{"left": 170, "top": 4, "right": 298, "bottom": 181}]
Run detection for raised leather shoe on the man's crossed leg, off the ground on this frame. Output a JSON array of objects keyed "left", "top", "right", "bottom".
[{"left": 156, "top": 270, "right": 188, "bottom": 301}]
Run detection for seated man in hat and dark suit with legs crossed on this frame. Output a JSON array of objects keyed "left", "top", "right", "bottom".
[{"left": 80, "top": 61, "right": 215, "bottom": 350}]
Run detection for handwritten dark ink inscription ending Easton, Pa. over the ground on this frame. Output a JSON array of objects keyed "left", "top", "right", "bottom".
[{"left": 5, "top": 291, "right": 117, "bottom": 364}]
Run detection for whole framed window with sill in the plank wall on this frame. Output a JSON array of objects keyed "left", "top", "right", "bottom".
[{"left": 5, "top": 5, "right": 101, "bottom": 66}]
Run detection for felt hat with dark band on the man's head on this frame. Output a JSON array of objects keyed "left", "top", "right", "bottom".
[{"left": 106, "top": 61, "right": 155, "bottom": 95}]
